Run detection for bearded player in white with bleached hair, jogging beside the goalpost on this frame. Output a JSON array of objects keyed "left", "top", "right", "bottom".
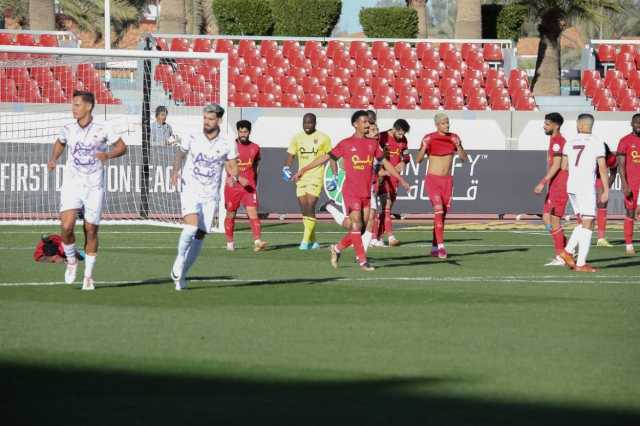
[{"left": 171, "top": 104, "right": 241, "bottom": 290}]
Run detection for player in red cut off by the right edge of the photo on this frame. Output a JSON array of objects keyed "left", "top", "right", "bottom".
[{"left": 616, "top": 114, "right": 640, "bottom": 256}]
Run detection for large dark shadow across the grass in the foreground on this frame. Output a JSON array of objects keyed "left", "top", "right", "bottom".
[{"left": 0, "top": 362, "right": 640, "bottom": 426}]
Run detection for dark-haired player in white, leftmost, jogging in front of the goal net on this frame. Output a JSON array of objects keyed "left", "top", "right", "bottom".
[{"left": 47, "top": 91, "right": 127, "bottom": 290}]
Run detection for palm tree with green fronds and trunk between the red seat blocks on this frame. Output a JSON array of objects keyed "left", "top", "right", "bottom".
[{"left": 517, "top": 0, "right": 622, "bottom": 96}]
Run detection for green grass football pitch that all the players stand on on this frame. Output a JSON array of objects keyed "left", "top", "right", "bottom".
[{"left": 0, "top": 223, "right": 640, "bottom": 425}]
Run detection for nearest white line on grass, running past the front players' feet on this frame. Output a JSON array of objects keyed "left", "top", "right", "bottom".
[{"left": 0, "top": 275, "right": 640, "bottom": 287}]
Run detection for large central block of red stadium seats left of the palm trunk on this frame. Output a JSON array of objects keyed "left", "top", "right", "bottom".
[{"left": 155, "top": 37, "right": 536, "bottom": 110}]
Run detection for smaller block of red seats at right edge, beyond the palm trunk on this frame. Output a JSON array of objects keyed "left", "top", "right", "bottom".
[{"left": 582, "top": 44, "right": 640, "bottom": 111}]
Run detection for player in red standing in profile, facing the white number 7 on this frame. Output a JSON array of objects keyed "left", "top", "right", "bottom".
[{"left": 533, "top": 112, "right": 569, "bottom": 266}]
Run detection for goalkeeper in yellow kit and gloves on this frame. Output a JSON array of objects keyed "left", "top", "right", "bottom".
[{"left": 282, "top": 113, "right": 331, "bottom": 250}]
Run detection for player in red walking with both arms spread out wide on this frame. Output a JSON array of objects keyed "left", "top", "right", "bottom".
[{"left": 295, "top": 110, "right": 409, "bottom": 271}]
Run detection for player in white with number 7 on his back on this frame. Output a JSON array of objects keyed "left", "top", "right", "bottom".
[{"left": 562, "top": 114, "right": 609, "bottom": 272}]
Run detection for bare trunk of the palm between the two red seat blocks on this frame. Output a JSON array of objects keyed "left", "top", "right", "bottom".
[{"left": 531, "top": 11, "right": 563, "bottom": 96}]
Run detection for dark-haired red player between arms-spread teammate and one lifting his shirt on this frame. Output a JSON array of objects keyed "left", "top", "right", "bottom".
[{"left": 374, "top": 118, "right": 410, "bottom": 247}]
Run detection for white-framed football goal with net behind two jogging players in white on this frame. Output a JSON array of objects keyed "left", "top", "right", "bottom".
[{"left": 0, "top": 38, "right": 227, "bottom": 230}]
